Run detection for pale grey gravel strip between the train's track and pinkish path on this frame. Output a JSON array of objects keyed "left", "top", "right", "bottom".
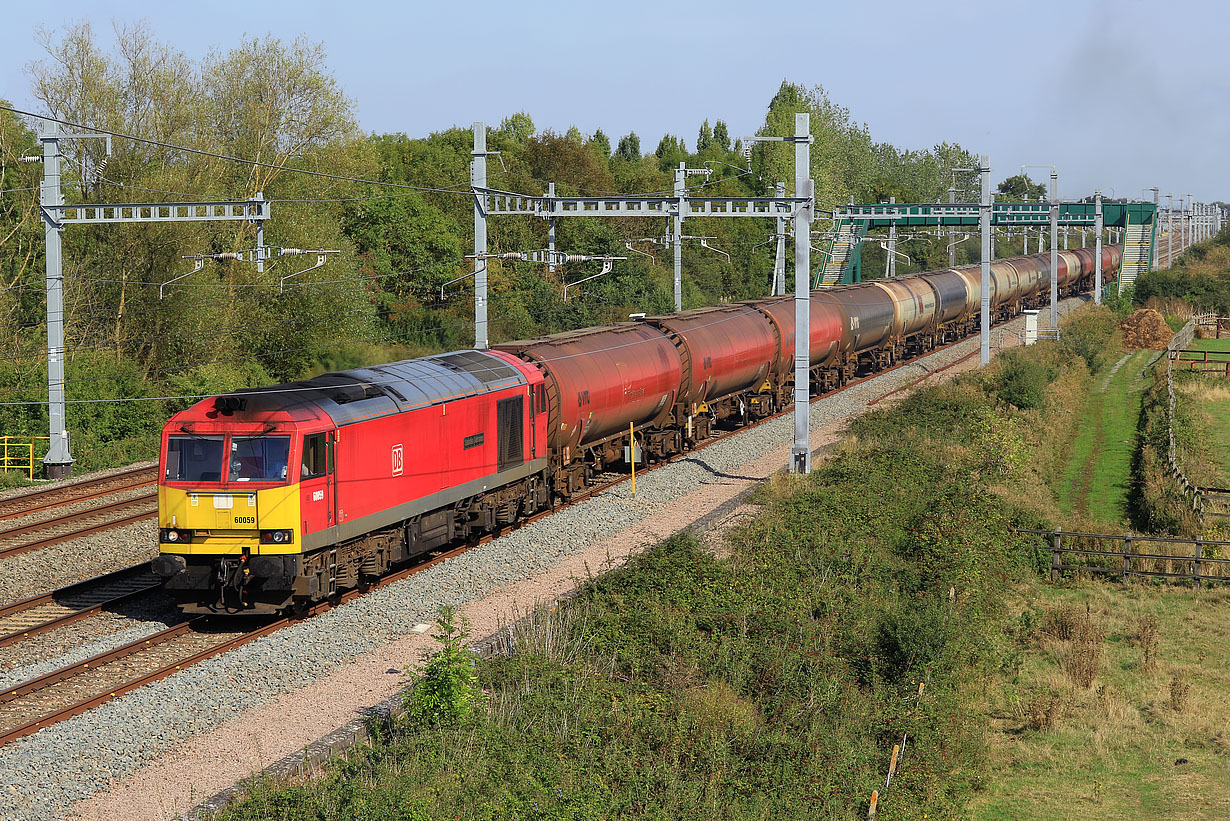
[{"left": 0, "top": 304, "right": 1087, "bottom": 819}]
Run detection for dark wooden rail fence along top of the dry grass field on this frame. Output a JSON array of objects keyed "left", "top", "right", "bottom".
[{"left": 1017, "top": 528, "right": 1230, "bottom": 587}]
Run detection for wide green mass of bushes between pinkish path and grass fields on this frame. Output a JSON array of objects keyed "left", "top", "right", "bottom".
[{"left": 219, "top": 310, "right": 1131, "bottom": 820}]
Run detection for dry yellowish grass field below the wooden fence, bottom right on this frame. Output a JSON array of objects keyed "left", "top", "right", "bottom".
[{"left": 969, "top": 582, "right": 1230, "bottom": 821}]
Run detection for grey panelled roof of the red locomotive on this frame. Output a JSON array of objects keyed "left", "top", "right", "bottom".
[{"left": 205, "top": 351, "right": 526, "bottom": 426}]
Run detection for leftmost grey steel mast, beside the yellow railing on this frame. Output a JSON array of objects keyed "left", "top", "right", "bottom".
[{"left": 38, "top": 119, "right": 75, "bottom": 479}]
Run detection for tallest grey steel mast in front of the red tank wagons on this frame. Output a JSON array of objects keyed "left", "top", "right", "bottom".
[{"left": 791, "top": 113, "right": 813, "bottom": 474}]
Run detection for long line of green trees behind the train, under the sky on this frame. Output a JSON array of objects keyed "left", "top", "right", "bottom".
[{"left": 0, "top": 23, "right": 977, "bottom": 462}]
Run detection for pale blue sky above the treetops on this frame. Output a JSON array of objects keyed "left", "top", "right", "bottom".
[{"left": 0, "top": 0, "right": 1230, "bottom": 202}]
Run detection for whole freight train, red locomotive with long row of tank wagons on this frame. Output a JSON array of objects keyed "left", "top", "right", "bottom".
[{"left": 153, "top": 246, "right": 1121, "bottom": 613}]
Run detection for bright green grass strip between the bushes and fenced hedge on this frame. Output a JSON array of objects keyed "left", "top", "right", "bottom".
[{"left": 1058, "top": 351, "right": 1157, "bottom": 524}]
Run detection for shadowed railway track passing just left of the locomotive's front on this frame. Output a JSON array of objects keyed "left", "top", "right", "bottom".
[{"left": 0, "top": 565, "right": 161, "bottom": 647}]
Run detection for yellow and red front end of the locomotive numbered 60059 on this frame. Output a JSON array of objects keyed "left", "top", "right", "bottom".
[{"left": 153, "top": 409, "right": 303, "bottom": 614}]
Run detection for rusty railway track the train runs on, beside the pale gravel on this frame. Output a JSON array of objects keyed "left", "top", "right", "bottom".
[{"left": 0, "top": 300, "right": 1067, "bottom": 745}]
